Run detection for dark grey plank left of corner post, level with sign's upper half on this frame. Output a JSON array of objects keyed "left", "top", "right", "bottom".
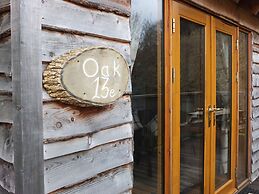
[{"left": 0, "top": 36, "right": 11, "bottom": 75}]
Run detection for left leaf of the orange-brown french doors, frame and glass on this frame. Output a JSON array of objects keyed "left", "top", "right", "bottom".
[{"left": 172, "top": 2, "right": 211, "bottom": 194}]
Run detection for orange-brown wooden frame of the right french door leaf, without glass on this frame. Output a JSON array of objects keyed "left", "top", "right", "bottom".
[{"left": 210, "top": 16, "right": 238, "bottom": 194}]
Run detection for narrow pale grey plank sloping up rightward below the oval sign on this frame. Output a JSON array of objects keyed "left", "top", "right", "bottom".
[{"left": 44, "top": 124, "right": 133, "bottom": 160}]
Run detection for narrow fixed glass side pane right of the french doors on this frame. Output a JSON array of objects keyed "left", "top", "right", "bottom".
[{"left": 237, "top": 32, "right": 248, "bottom": 184}]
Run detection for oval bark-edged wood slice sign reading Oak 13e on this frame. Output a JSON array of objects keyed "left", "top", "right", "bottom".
[{"left": 43, "top": 47, "right": 132, "bottom": 107}]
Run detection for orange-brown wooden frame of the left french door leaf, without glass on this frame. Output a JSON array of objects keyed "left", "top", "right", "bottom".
[{"left": 170, "top": 1, "right": 211, "bottom": 193}]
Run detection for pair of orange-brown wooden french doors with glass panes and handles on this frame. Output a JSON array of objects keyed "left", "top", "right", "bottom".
[{"left": 171, "top": 2, "right": 238, "bottom": 194}]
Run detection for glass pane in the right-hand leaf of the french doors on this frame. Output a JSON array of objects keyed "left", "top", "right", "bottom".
[{"left": 215, "top": 31, "right": 232, "bottom": 188}]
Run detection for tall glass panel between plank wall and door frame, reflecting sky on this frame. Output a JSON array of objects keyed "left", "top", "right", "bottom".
[{"left": 131, "top": 0, "right": 164, "bottom": 194}]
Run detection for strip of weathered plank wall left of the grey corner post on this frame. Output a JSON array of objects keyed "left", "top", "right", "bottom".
[{"left": 0, "top": 0, "right": 15, "bottom": 194}]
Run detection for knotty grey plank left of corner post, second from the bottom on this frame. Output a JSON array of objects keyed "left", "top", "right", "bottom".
[{"left": 0, "top": 123, "right": 14, "bottom": 163}]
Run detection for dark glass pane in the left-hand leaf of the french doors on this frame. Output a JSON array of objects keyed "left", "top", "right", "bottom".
[{"left": 180, "top": 19, "right": 205, "bottom": 194}]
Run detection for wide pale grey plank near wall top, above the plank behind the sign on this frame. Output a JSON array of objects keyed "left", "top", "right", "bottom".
[{"left": 42, "top": 0, "right": 131, "bottom": 42}]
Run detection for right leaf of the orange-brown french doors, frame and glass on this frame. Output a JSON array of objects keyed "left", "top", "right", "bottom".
[{"left": 211, "top": 19, "right": 238, "bottom": 193}]
